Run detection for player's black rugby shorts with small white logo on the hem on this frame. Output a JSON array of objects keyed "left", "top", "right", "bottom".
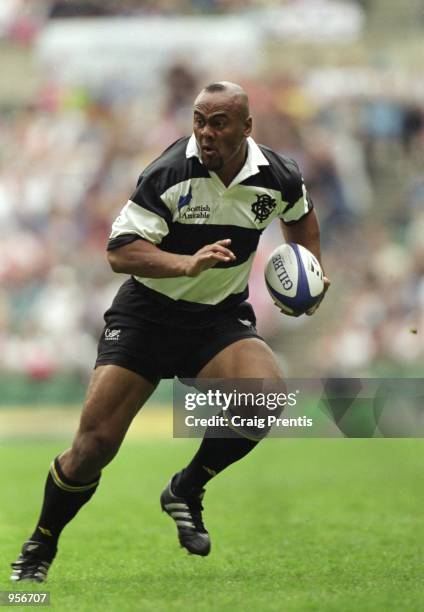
[{"left": 96, "top": 302, "right": 262, "bottom": 384}]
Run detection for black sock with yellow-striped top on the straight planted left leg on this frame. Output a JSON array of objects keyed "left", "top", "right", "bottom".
[{"left": 30, "top": 457, "right": 100, "bottom": 553}]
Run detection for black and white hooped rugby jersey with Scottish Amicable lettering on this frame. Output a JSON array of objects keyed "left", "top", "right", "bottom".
[{"left": 108, "top": 135, "right": 312, "bottom": 326}]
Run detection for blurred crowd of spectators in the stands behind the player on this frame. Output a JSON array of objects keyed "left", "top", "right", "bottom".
[{"left": 0, "top": 0, "right": 424, "bottom": 379}]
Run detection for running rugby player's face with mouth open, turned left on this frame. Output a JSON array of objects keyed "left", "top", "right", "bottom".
[{"left": 193, "top": 92, "right": 252, "bottom": 173}]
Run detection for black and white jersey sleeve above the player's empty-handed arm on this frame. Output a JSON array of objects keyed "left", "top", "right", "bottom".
[{"left": 107, "top": 175, "right": 171, "bottom": 251}]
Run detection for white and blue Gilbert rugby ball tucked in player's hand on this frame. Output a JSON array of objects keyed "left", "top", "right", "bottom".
[{"left": 265, "top": 242, "right": 324, "bottom": 316}]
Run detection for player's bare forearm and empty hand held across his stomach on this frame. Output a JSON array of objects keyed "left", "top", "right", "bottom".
[{"left": 107, "top": 239, "right": 235, "bottom": 278}]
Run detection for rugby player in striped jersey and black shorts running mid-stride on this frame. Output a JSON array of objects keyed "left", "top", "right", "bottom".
[{"left": 11, "top": 81, "right": 329, "bottom": 582}]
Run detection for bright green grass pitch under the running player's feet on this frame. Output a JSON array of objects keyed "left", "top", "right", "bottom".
[{"left": 0, "top": 439, "right": 424, "bottom": 612}]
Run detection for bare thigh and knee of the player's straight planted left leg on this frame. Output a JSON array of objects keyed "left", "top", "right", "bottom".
[{"left": 59, "top": 365, "right": 155, "bottom": 482}]
